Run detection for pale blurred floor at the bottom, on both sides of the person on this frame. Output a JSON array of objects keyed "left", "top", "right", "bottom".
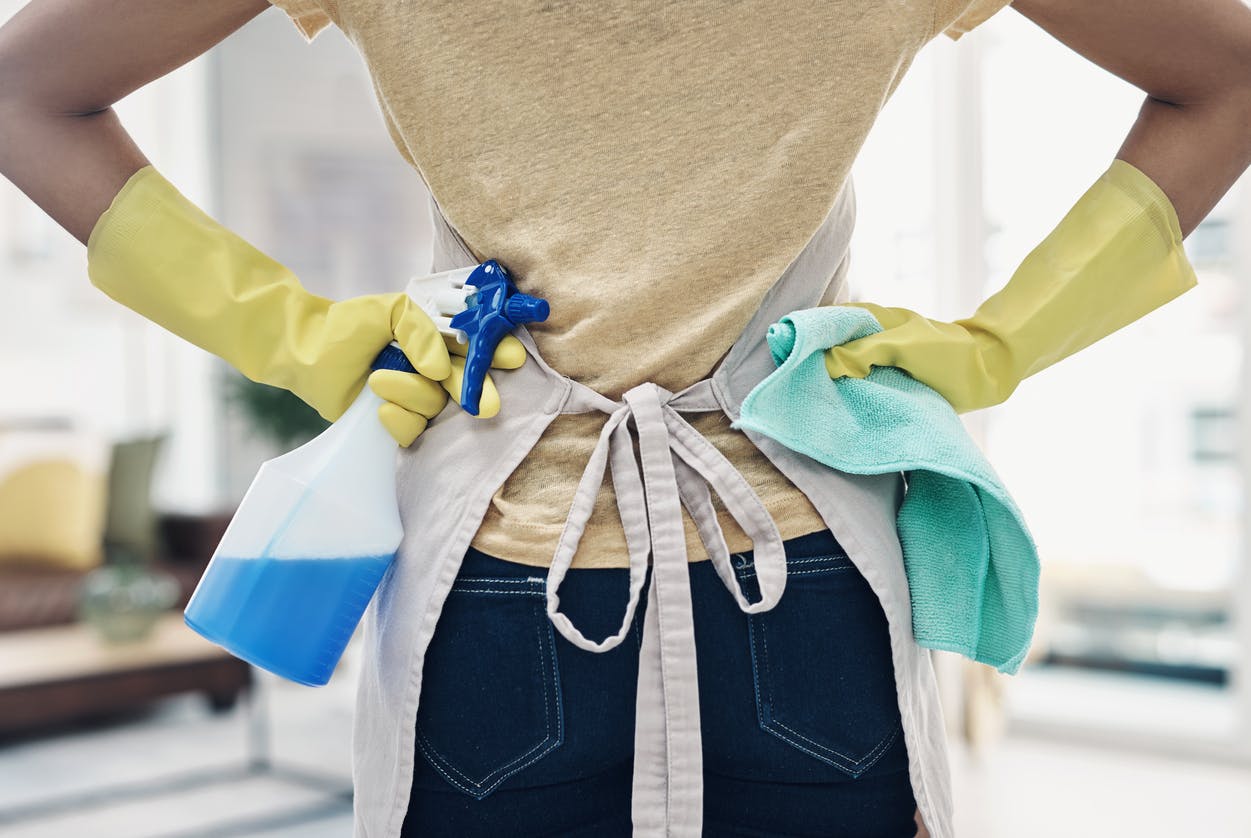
[{"left": 0, "top": 637, "right": 1251, "bottom": 838}]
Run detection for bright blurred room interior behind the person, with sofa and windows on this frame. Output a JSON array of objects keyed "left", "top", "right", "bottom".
[{"left": 0, "top": 0, "right": 1251, "bottom": 838}]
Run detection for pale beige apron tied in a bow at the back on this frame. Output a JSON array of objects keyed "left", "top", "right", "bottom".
[{"left": 353, "top": 181, "right": 952, "bottom": 838}]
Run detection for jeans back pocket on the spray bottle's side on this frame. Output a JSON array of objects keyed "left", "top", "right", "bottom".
[{"left": 417, "top": 577, "right": 564, "bottom": 799}]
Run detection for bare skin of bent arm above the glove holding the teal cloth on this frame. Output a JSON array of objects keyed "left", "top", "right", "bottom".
[{"left": 1012, "top": 0, "right": 1251, "bottom": 235}]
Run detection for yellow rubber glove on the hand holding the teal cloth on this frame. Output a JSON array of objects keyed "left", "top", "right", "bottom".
[{"left": 826, "top": 159, "right": 1198, "bottom": 413}]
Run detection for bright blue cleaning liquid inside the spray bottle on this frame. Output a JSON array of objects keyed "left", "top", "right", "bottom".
[{"left": 184, "top": 555, "right": 394, "bottom": 687}]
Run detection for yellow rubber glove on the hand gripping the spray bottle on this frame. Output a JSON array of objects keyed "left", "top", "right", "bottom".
[{"left": 88, "top": 165, "right": 525, "bottom": 445}]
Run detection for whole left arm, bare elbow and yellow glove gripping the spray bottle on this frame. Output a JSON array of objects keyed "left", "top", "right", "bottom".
[{"left": 0, "top": 0, "right": 507, "bottom": 445}]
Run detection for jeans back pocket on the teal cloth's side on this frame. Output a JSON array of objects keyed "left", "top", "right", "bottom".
[{"left": 736, "top": 544, "right": 902, "bottom": 778}]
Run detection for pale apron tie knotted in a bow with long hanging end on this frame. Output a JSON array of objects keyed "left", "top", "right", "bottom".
[{"left": 547, "top": 379, "right": 786, "bottom": 837}]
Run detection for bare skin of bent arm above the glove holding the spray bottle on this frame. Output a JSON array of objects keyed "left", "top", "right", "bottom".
[{"left": 0, "top": 0, "right": 269, "bottom": 244}]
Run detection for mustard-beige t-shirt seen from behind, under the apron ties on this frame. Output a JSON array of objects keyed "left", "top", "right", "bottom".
[{"left": 270, "top": 0, "right": 1010, "bottom": 567}]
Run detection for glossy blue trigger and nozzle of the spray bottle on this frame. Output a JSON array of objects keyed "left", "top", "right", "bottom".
[{"left": 452, "top": 259, "right": 550, "bottom": 416}]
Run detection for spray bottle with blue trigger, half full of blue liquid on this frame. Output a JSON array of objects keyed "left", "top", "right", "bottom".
[{"left": 183, "top": 259, "right": 548, "bottom": 687}]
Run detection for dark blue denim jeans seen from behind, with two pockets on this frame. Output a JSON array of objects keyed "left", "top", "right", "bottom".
[{"left": 403, "top": 530, "right": 916, "bottom": 838}]
